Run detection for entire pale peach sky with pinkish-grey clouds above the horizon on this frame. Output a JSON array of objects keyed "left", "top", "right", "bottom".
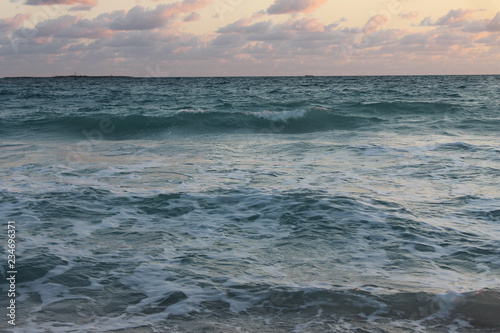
[{"left": 0, "top": 0, "right": 500, "bottom": 77}]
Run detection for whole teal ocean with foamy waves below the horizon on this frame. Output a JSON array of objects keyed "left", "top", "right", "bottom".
[{"left": 0, "top": 75, "right": 500, "bottom": 333}]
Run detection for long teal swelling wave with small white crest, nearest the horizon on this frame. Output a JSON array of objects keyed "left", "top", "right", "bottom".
[{"left": 8, "top": 107, "right": 382, "bottom": 137}]
